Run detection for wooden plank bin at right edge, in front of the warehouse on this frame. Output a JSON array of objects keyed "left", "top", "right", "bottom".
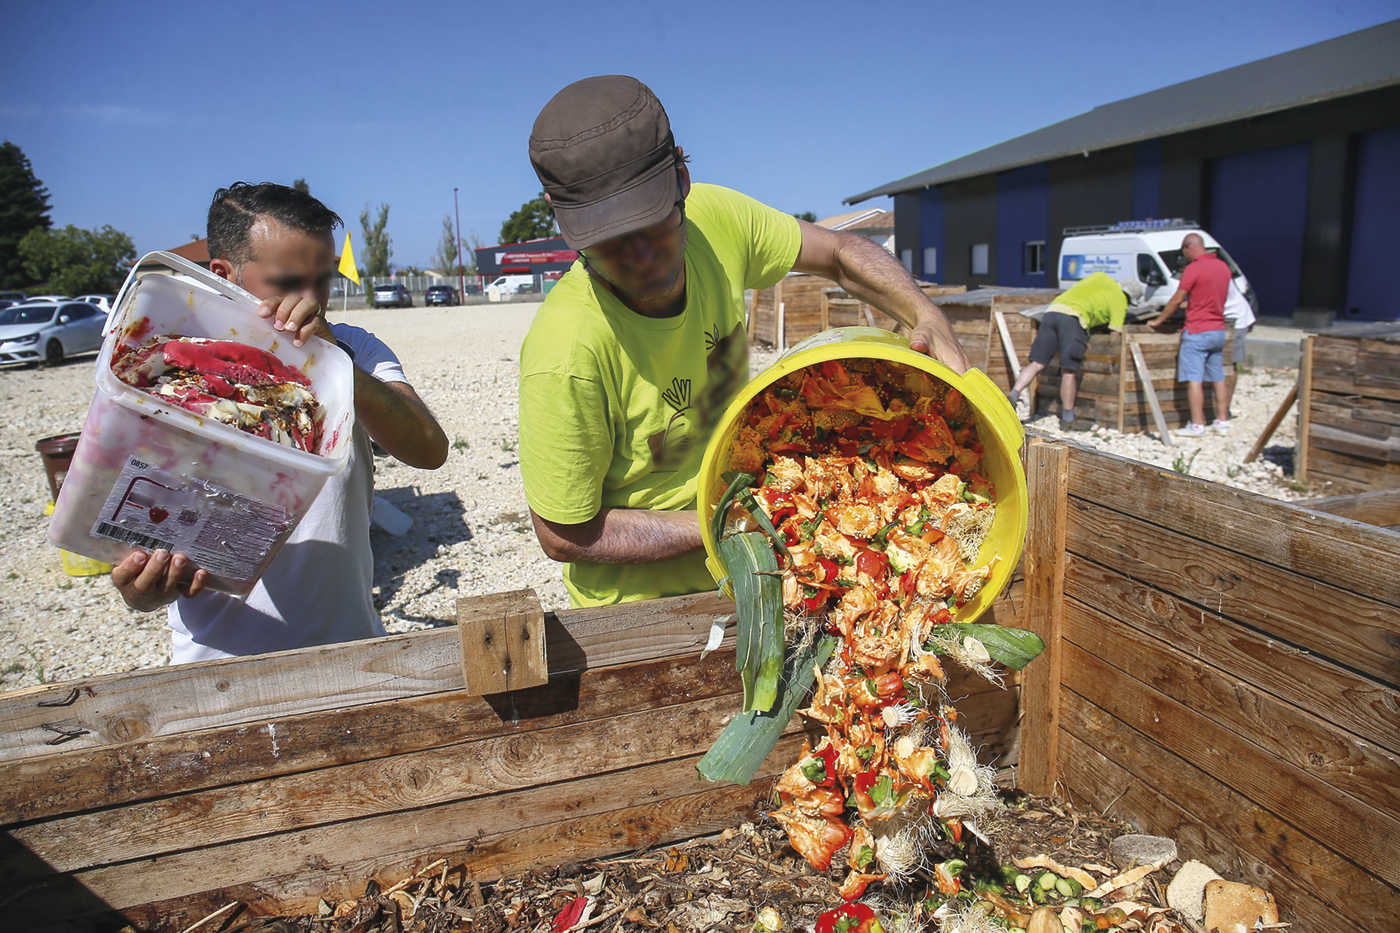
[{"left": 1295, "top": 324, "right": 1400, "bottom": 492}]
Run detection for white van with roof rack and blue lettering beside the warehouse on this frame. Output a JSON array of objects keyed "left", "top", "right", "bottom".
[{"left": 1060, "top": 219, "right": 1259, "bottom": 310}]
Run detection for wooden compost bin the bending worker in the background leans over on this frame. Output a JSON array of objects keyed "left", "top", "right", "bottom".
[{"left": 1036, "top": 324, "right": 1235, "bottom": 434}]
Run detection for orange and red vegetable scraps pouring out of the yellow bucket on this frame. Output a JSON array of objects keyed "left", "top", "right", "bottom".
[{"left": 720, "top": 359, "right": 1040, "bottom": 899}]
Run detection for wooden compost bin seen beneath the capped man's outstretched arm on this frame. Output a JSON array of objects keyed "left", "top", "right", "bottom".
[{"left": 749, "top": 273, "right": 967, "bottom": 349}]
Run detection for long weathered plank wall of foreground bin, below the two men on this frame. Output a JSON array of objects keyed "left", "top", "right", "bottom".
[{"left": 0, "top": 579, "right": 1023, "bottom": 933}]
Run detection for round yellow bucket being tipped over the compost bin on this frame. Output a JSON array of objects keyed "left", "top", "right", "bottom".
[{"left": 697, "top": 328, "right": 1030, "bottom": 622}]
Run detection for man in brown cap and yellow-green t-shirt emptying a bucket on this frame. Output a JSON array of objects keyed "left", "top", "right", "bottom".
[{"left": 519, "top": 74, "right": 969, "bottom": 607}]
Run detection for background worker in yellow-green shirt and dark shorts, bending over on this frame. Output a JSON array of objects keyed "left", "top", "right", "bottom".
[{"left": 1009, "top": 272, "right": 1142, "bottom": 431}]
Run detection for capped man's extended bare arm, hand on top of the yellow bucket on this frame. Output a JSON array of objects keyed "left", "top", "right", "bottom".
[{"left": 792, "top": 220, "right": 972, "bottom": 373}]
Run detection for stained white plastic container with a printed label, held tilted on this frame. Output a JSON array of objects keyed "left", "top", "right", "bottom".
[{"left": 49, "top": 252, "right": 354, "bottom": 595}]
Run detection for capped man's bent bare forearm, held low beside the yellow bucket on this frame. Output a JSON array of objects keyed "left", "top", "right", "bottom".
[{"left": 529, "top": 509, "right": 704, "bottom": 563}]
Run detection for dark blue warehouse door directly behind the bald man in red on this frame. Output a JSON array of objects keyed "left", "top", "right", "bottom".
[{"left": 1210, "top": 143, "right": 1309, "bottom": 318}]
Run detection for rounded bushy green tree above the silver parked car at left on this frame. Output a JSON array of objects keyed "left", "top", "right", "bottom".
[{"left": 20, "top": 224, "right": 136, "bottom": 294}]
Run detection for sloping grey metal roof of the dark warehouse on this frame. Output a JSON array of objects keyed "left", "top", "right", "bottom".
[{"left": 846, "top": 20, "right": 1400, "bottom": 205}]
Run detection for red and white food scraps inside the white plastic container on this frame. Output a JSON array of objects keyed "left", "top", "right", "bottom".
[{"left": 112, "top": 335, "right": 323, "bottom": 454}]
